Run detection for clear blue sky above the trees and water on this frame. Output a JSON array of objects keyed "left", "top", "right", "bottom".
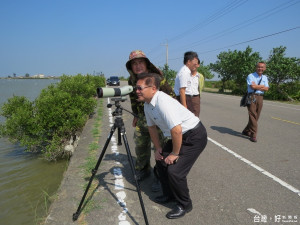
[{"left": 0, "top": 0, "right": 300, "bottom": 77}]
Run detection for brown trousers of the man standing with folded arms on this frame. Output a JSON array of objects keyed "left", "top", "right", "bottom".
[{"left": 243, "top": 95, "right": 264, "bottom": 138}]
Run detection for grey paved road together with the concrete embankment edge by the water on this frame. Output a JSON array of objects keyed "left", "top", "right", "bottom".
[{"left": 45, "top": 84, "right": 300, "bottom": 225}]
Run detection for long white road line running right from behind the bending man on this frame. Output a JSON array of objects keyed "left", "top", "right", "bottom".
[{"left": 207, "top": 137, "right": 300, "bottom": 196}]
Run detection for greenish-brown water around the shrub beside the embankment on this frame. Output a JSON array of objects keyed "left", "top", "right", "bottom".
[{"left": 0, "top": 79, "right": 67, "bottom": 225}]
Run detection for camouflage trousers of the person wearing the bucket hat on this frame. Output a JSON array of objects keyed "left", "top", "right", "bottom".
[{"left": 133, "top": 114, "right": 166, "bottom": 170}]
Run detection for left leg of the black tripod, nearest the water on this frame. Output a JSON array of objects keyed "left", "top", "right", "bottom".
[{"left": 73, "top": 125, "right": 116, "bottom": 221}]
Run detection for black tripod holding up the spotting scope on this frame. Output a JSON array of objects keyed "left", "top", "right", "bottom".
[{"left": 73, "top": 98, "right": 149, "bottom": 225}]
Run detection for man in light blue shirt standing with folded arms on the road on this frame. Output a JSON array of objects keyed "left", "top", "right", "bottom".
[{"left": 242, "top": 62, "right": 269, "bottom": 142}]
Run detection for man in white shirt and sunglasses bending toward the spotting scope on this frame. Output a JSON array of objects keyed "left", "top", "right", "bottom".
[{"left": 136, "top": 73, "right": 207, "bottom": 219}]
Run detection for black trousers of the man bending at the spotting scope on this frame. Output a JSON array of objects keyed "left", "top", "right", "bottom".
[{"left": 156, "top": 122, "right": 207, "bottom": 208}]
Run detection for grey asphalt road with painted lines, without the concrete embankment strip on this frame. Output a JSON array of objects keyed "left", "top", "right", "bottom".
[{"left": 94, "top": 83, "right": 300, "bottom": 225}]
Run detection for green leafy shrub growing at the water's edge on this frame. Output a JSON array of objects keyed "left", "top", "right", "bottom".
[{"left": 0, "top": 74, "right": 105, "bottom": 160}]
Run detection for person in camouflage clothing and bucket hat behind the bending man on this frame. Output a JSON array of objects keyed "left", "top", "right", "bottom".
[{"left": 126, "top": 50, "right": 174, "bottom": 191}]
